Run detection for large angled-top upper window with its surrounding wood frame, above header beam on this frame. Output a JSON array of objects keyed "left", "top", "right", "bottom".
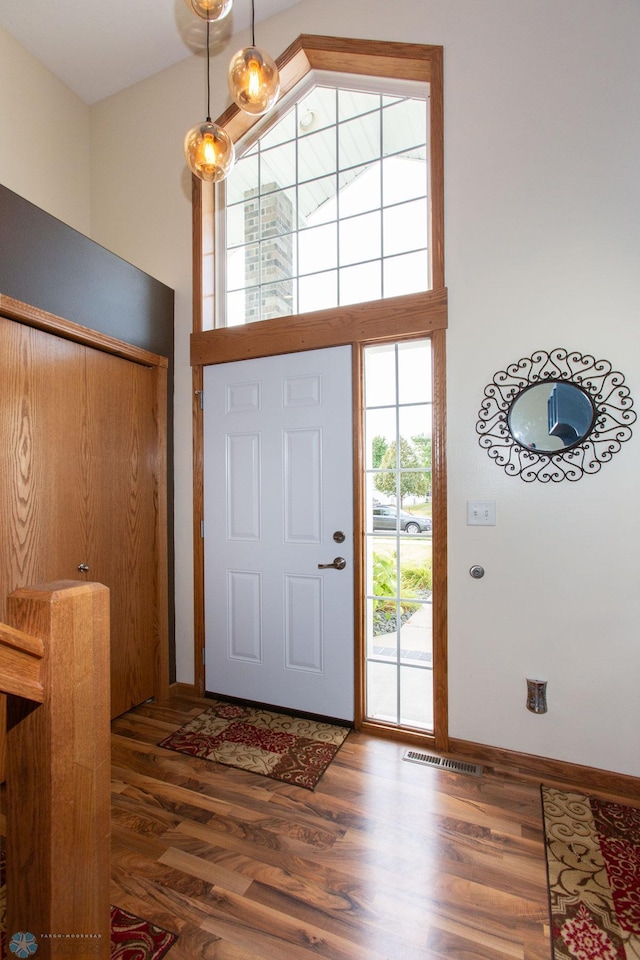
[{"left": 194, "top": 36, "right": 444, "bottom": 331}]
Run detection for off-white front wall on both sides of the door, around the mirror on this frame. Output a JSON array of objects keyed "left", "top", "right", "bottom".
[{"left": 0, "top": 0, "right": 640, "bottom": 776}]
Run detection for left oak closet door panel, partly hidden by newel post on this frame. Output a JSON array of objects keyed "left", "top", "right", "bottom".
[{"left": 0, "top": 317, "right": 87, "bottom": 622}]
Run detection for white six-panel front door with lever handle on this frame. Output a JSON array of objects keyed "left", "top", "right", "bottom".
[{"left": 204, "top": 347, "right": 354, "bottom": 721}]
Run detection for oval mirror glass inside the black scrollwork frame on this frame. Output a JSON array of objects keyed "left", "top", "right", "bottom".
[{"left": 508, "top": 380, "right": 596, "bottom": 453}]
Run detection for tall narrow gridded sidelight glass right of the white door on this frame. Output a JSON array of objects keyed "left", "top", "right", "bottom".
[{"left": 363, "top": 340, "right": 434, "bottom": 731}]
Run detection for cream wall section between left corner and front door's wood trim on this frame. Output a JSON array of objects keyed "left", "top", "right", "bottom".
[{"left": 92, "top": 57, "right": 205, "bottom": 683}]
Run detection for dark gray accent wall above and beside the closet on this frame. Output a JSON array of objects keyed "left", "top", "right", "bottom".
[{"left": 0, "top": 184, "right": 175, "bottom": 680}]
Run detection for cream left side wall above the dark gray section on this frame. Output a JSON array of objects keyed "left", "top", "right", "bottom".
[{"left": 0, "top": 28, "right": 91, "bottom": 234}]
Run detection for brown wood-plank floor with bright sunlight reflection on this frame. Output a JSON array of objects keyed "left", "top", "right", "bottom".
[{"left": 111, "top": 698, "right": 550, "bottom": 960}]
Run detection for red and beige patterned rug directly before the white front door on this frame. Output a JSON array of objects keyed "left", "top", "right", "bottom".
[{"left": 159, "top": 700, "right": 349, "bottom": 790}]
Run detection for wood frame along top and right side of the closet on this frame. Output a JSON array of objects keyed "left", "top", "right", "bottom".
[{"left": 0, "top": 293, "right": 169, "bottom": 700}]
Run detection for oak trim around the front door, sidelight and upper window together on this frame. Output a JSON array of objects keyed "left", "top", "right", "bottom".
[{"left": 191, "top": 34, "right": 448, "bottom": 750}]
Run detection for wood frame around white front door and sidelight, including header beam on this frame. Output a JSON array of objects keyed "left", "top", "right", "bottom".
[{"left": 191, "top": 290, "right": 448, "bottom": 750}]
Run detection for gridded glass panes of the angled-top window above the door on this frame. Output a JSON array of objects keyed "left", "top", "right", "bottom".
[{"left": 217, "top": 81, "right": 430, "bottom": 326}]
